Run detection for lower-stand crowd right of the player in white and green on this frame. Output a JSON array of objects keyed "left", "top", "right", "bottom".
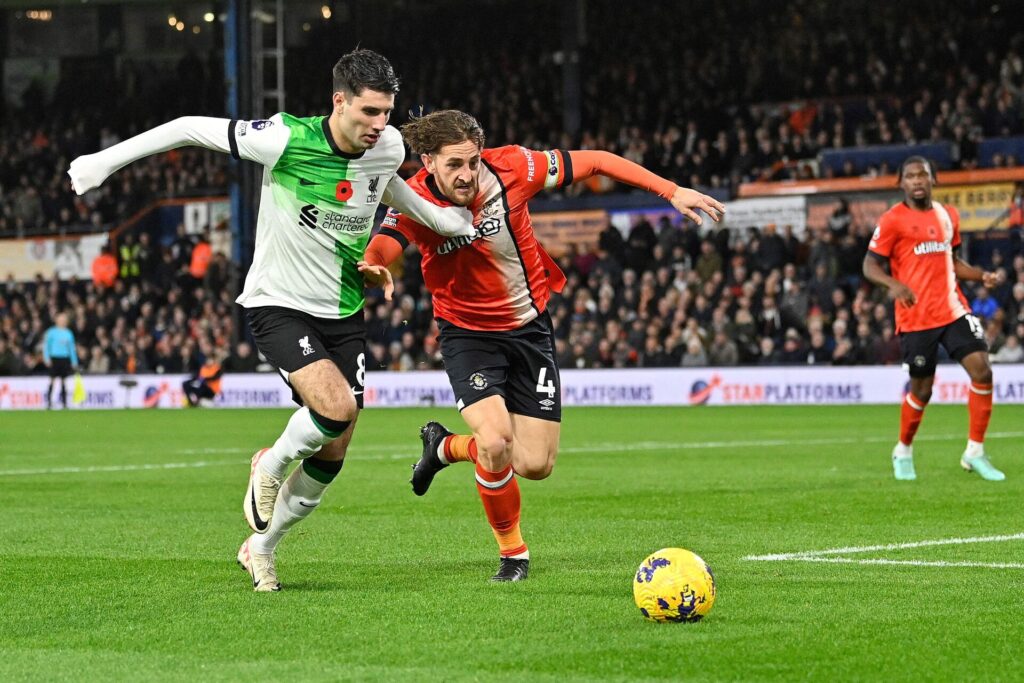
[{"left": 367, "top": 219, "right": 1024, "bottom": 370}]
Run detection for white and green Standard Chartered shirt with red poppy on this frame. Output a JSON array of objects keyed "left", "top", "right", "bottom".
[{"left": 232, "top": 114, "right": 406, "bottom": 318}]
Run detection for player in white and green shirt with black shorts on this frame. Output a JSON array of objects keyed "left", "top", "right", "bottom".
[{"left": 69, "top": 50, "right": 473, "bottom": 592}]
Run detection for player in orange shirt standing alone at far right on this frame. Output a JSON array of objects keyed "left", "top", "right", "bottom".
[{"left": 864, "top": 157, "right": 1006, "bottom": 481}]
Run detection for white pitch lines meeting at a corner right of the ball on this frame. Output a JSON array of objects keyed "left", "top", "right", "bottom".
[{"left": 741, "top": 532, "right": 1024, "bottom": 569}]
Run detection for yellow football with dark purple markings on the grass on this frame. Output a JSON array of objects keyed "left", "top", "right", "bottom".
[{"left": 633, "top": 548, "right": 715, "bottom": 622}]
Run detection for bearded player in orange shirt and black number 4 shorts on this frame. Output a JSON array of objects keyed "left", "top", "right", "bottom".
[{"left": 362, "top": 111, "right": 723, "bottom": 582}]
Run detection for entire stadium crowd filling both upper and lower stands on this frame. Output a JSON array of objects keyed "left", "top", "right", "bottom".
[{"left": 0, "top": 0, "right": 1024, "bottom": 376}]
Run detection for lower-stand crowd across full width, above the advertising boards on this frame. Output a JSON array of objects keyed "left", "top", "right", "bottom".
[{"left": 0, "top": 218, "right": 1024, "bottom": 376}]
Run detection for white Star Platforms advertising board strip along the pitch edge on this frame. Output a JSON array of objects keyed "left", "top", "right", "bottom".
[{"left": 0, "top": 365, "right": 1024, "bottom": 411}]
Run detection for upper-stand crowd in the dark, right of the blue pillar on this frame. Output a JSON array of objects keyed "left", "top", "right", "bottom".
[{"left": 291, "top": 0, "right": 1024, "bottom": 191}]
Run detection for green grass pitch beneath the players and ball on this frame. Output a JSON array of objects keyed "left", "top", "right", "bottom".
[{"left": 0, "top": 405, "right": 1024, "bottom": 681}]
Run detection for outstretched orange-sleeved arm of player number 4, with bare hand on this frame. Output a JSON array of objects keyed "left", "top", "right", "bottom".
[{"left": 569, "top": 150, "right": 725, "bottom": 225}]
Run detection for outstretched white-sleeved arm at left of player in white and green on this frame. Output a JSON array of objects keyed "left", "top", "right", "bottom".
[{"left": 68, "top": 116, "right": 262, "bottom": 195}]
